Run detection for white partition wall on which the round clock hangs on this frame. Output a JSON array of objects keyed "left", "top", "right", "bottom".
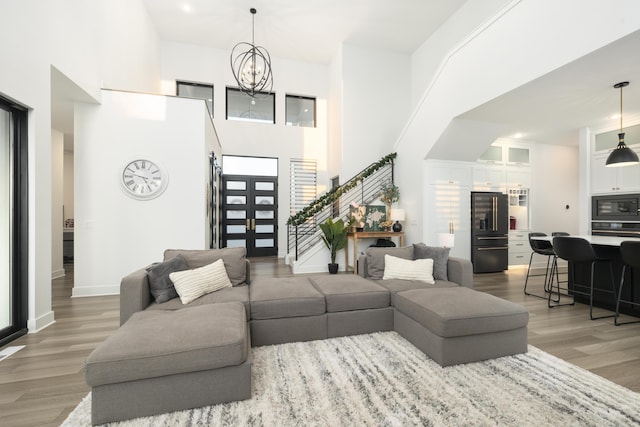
[{"left": 73, "top": 91, "right": 209, "bottom": 296}]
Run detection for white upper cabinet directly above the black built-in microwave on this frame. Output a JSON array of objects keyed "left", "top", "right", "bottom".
[{"left": 591, "top": 152, "right": 640, "bottom": 194}]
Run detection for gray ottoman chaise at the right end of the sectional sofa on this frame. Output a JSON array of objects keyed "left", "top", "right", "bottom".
[{"left": 394, "top": 287, "right": 529, "bottom": 366}]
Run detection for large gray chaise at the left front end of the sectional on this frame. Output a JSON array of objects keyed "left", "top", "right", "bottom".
[{"left": 85, "top": 302, "right": 251, "bottom": 425}]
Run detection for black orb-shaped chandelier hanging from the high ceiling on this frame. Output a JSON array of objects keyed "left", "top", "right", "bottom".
[{"left": 231, "top": 8, "right": 273, "bottom": 104}]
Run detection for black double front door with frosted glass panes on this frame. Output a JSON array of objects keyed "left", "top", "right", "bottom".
[{"left": 221, "top": 175, "right": 278, "bottom": 256}]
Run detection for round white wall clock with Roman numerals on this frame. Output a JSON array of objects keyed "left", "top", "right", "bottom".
[{"left": 120, "top": 159, "right": 169, "bottom": 200}]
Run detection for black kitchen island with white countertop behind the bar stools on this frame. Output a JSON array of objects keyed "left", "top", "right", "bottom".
[{"left": 532, "top": 235, "right": 640, "bottom": 317}]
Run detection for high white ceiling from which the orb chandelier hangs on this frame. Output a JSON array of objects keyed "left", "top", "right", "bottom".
[{"left": 143, "top": 0, "right": 465, "bottom": 63}]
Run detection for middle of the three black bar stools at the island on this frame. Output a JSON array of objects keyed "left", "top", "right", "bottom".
[{"left": 547, "top": 236, "right": 617, "bottom": 320}]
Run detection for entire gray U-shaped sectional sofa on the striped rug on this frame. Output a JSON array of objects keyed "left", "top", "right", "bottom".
[{"left": 85, "top": 244, "right": 528, "bottom": 424}]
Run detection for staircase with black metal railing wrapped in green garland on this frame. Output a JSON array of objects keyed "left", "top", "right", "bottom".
[{"left": 287, "top": 153, "right": 396, "bottom": 260}]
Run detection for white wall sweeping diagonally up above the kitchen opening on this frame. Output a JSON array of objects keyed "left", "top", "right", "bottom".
[{"left": 396, "top": 0, "right": 640, "bottom": 247}]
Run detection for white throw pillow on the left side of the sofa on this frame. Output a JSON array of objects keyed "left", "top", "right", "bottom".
[{"left": 169, "top": 259, "right": 231, "bottom": 304}]
